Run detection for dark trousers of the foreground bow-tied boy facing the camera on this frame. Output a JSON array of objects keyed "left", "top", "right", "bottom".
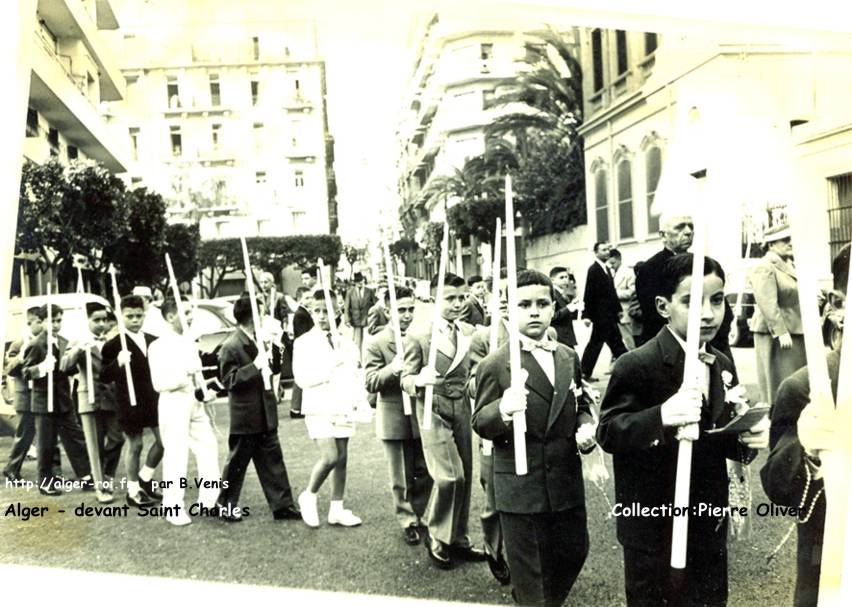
[{"left": 500, "top": 506, "right": 589, "bottom": 607}]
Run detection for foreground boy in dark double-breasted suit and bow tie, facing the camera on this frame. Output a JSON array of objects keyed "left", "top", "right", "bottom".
[{"left": 473, "top": 270, "right": 595, "bottom": 606}]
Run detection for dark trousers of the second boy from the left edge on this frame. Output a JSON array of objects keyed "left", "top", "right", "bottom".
[{"left": 34, "top": 410, "right": 92, "bottom": 483}]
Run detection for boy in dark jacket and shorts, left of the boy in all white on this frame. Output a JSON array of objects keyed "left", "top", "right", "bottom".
[{"left": 100, "top": 295, "right": 163, "bottom": 508}]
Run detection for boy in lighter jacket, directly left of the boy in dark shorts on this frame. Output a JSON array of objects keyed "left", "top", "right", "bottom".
[{"left": 59, "top": 302, "right": 124, "bottom": 503}]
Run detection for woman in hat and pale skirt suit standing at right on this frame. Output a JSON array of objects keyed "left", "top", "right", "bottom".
[{"left": 750, "top": 224, "right": 806, "bottom": 405}]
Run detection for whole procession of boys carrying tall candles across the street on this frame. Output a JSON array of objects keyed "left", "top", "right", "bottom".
[{"left": 4, "top": 213, "right": 849, "bottom": 607}]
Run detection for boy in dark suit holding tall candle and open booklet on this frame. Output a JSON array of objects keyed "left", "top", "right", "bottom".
[{"left": 597, "top": 254, "right": 768, "bottom": 607}]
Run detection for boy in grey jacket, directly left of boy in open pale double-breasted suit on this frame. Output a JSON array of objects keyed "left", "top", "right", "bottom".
[{"left": 364, "top": 287, "right": 432, "bottom": 546}]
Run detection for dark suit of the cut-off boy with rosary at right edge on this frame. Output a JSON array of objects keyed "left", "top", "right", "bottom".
[{"left": 760, "top": 352, "right": 840, "bottom": 605}]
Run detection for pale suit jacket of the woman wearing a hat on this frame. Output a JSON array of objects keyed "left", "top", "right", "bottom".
[{"left": 749, "top": 251, "right": 803, "bottom": 337}]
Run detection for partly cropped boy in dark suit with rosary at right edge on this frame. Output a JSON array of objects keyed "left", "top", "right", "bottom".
[{"left": 760, "top": 245, "right": 850, "bottom": 607}]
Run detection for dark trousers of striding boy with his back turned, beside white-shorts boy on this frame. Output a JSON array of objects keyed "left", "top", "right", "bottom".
[{"left": 218, "top": 430, "right": 293, "bottom": 512}]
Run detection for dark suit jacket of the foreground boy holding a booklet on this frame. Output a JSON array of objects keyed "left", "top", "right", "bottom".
[{"left": 597, "top": 329, "right": 756, "bottom": 550}]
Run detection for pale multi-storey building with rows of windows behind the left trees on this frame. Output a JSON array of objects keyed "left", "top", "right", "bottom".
[{"left": 110, "top": 7, "right": 337, "bottom": 239}]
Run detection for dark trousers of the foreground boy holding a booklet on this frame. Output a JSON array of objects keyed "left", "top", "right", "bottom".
[{"left": 624, "top": 544, "right": 728, "bottom": 607}]
